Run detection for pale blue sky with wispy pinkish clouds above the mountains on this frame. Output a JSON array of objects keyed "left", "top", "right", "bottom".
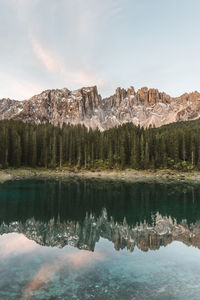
[{"left": 0, "top": 0, "right": 200, "bottom": 100}]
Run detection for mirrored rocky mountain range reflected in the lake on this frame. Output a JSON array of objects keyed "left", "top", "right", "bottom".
[{"left": 0, "top": 209, "right": 200, "bottom": 251}]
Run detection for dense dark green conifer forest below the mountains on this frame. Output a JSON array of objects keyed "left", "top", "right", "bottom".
[{"left": 0, "top": 120, "right": 200, "bottom": 170}]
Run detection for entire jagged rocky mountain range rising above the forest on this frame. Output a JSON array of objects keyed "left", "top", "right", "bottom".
[{"left": 0, "top": 86, "right": 200, "bottom": 130}]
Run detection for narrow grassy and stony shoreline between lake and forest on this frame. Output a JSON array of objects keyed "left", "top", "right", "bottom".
[{"left": 0, "top": 168, "right": 200, "bottom": 183}]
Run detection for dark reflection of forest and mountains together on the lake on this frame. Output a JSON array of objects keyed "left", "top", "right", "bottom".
[{"left": 0, "top": 180, "right": 200, "bottom": 251}]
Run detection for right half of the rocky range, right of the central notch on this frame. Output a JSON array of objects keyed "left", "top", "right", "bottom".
[{"left": 104, "top": 87, "right": 200, "bottom": 127}]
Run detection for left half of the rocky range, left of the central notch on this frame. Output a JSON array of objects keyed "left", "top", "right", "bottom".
[{"left": 0, "top": 87, "right": 102, "bottom": 127}]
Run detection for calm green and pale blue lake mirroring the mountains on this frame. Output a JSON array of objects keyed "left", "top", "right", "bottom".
[{"left": 0, "top": 180, "right": 200, "bottom": 300}]
